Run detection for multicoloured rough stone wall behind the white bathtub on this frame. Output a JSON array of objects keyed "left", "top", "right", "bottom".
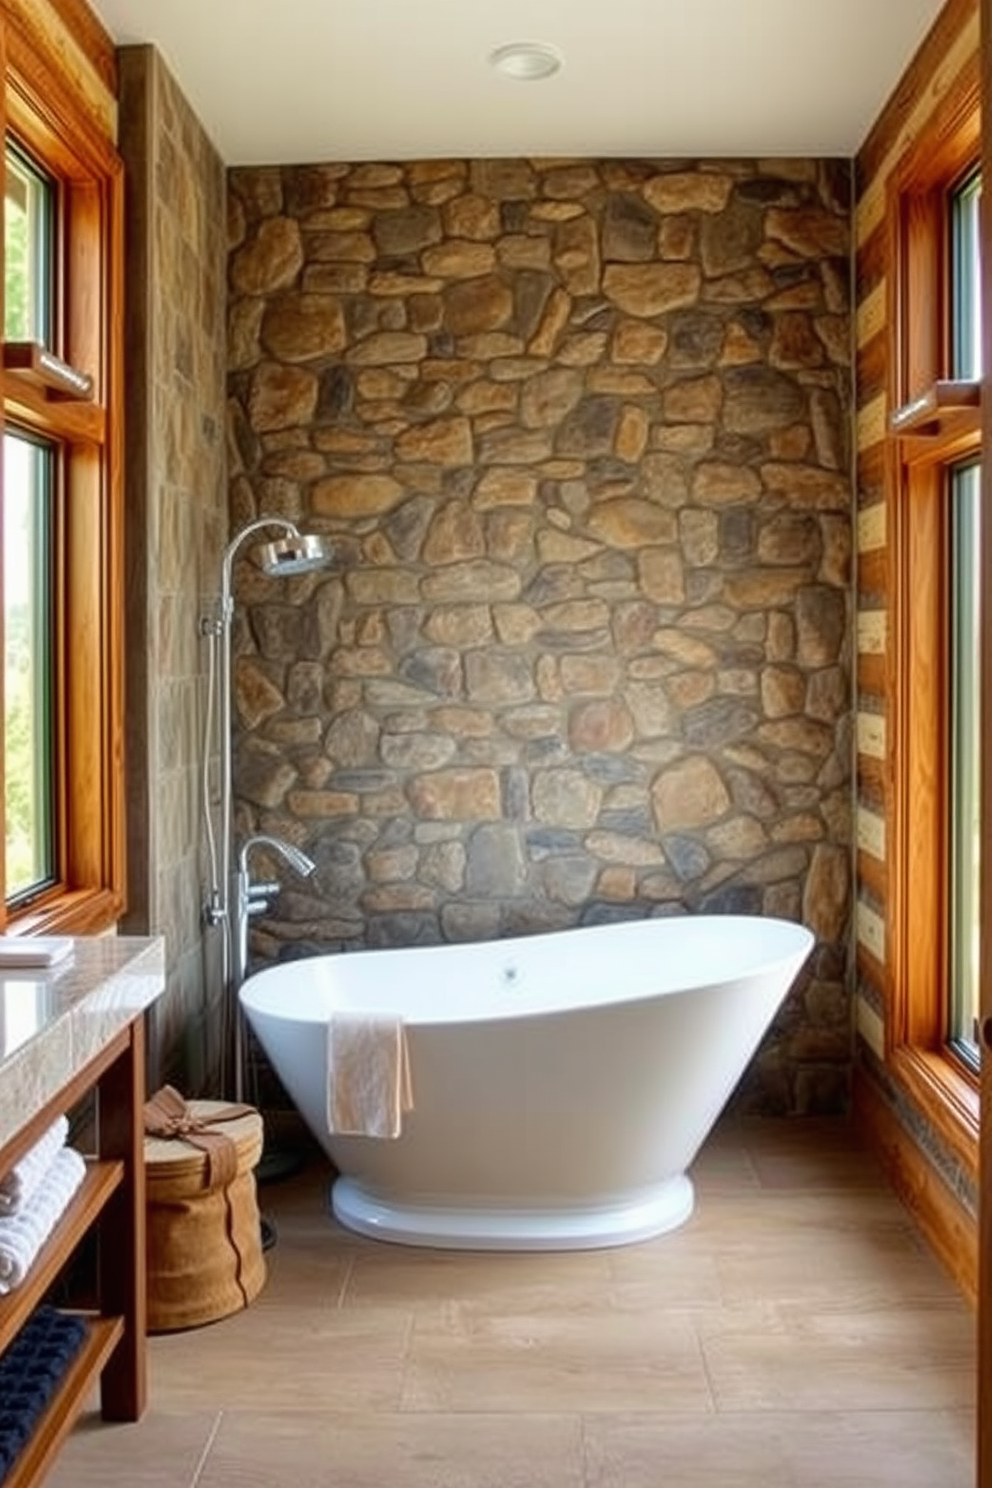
[{"left": 229, "top": 161, "right": 851, "bottom": 1110}]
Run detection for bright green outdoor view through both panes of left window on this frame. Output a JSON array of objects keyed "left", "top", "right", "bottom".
[{"left": 3, "top": 149, "right": 55, "bottom": 900}]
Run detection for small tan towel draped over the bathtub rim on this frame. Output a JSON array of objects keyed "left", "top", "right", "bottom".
[{"left": 327, "top": 1012, "right": 413, "bottom": 1137}]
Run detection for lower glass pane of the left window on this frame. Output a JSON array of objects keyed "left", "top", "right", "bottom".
[{"left": 3, "top": 433, "right": 57, "bottom": 903}]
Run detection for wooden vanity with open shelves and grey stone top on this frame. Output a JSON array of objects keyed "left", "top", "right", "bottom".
[{"left": 0, "top": 937, "right": 165, "bottom": 1488}]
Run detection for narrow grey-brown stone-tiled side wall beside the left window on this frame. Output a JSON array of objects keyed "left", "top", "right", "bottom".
[{"left": 119, "top": 46, "right": 228, "bottom": 1092}]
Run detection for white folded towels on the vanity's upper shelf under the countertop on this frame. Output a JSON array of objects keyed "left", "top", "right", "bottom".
[{"left": 0, "top": 1116, "right": 86, "bottom": 1296}]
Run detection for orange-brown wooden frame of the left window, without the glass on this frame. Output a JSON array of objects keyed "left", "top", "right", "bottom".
[{"left": 0, "top": 16, "right": 125, "bottom": 934}]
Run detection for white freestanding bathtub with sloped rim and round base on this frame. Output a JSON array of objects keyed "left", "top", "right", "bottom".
[{"left": 241, "top": 915, "right": 814, "bottom": 1250}]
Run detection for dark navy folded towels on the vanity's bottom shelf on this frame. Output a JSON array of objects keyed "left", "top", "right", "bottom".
[{"left": 0, "top": 1306, "right": 86, "bottom": 1484}]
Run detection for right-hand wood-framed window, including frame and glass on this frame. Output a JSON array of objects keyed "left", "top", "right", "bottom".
[{"left": 886, "top": 90, "right": 982, "bottom": 1165}]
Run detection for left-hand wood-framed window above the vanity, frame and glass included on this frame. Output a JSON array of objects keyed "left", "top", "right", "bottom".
[{"left": 0, "top": 15, "right": 123, "bottom": 933}]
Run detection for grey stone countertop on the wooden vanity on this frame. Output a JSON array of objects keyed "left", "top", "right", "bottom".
[{"left": 0, "top": 936, "right": 165, "bottom": 1147}]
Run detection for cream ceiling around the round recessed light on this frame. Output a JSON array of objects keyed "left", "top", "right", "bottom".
[{"left": 91, "top": 0, "right": 941, "bottom": 165}]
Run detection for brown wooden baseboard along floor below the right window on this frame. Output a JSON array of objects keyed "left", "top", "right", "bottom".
[{"left": 854, "top": 1068, "right": 979, "bottom": 1306}]
